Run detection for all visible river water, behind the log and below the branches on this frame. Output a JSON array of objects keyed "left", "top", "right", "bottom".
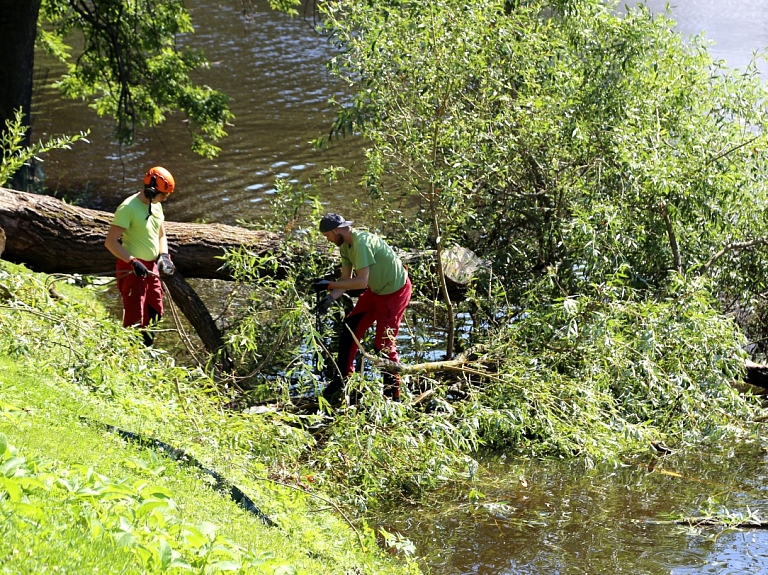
[{"left": 33, "top": 0, "right": 768, "bottom": 575}]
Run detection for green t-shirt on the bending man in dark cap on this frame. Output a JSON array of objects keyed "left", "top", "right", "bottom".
[{"left": 339, "top": 230, "right": 408, "bottom": 295}]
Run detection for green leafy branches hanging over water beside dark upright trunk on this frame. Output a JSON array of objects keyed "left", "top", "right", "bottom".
[{"left": 40, "top": 0, "right": 233, "bottom": 157}]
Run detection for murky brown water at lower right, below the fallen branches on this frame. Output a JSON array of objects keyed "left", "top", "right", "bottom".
[{"left": 382, "top": 447, "right": 768, "bottom": 575}]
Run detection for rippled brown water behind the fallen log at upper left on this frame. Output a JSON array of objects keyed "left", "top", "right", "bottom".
[{"left": 33, "top": 0, "right": 362, "bottom": 224}]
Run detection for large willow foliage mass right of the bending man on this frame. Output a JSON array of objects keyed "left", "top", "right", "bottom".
[{"left": 284, "top": 0, "right": 768, "bottom": 472}]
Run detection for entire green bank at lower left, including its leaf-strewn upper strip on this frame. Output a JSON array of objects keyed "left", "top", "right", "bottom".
[{"left": 0, "top": 262, "right": 419, "bottom": 574}]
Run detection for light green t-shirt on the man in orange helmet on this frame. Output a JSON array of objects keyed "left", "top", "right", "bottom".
[{"left": 112, "top": 192, "right": 165, "bottom": 261}]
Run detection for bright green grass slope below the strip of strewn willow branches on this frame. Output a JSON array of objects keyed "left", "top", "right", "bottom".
[{"left": 0, "top": 262, "right": 417, "bottom": 574}]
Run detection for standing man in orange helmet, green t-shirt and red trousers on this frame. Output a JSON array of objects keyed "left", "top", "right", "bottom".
[{"left": 104, "top": 166, "right": 176, "bottom": 345}]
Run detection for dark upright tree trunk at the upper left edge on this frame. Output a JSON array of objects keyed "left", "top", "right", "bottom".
[{"left": 0, "top": 0, "right": 41, "bottom": 188}]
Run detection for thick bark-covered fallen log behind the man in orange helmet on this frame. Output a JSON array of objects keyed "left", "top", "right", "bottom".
[{"left": 0, "top": 188, "right": 281, "bottom": 280}]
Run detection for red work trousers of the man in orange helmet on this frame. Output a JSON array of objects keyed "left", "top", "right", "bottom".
[{"left": 117, "top": 260, "right": 163, "bottom": 327}]
